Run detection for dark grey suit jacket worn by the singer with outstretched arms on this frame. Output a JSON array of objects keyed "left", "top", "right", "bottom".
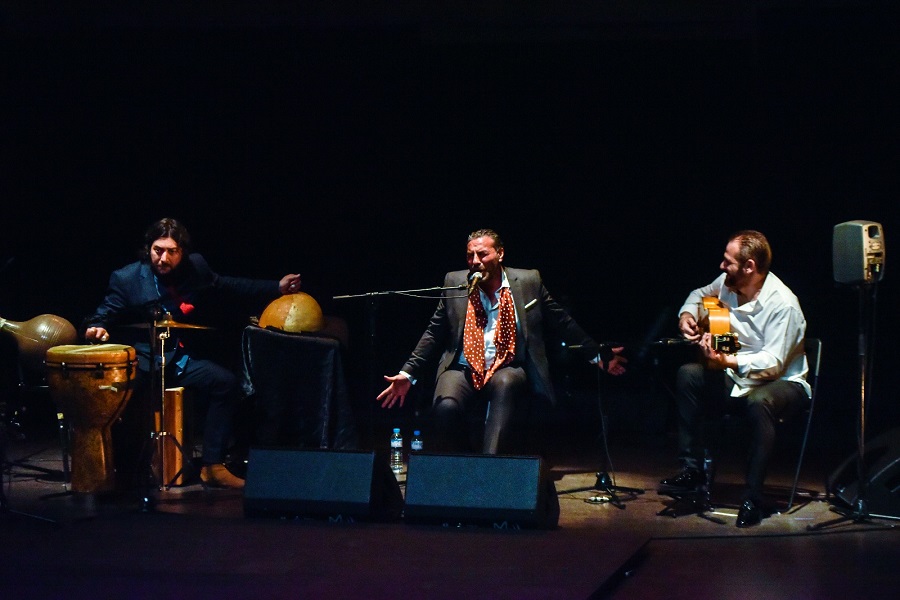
[{"left": 402, "top": 267, "right": 600, "bottom": 402}]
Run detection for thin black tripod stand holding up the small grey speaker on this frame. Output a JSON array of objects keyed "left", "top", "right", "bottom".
[{"left": 806, "top": 283, "right": 894, "bottom": 531}]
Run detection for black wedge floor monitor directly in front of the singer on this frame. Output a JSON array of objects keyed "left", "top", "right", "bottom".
[{"left": 403, "top": 454, "right": 559, "bottom": 529}]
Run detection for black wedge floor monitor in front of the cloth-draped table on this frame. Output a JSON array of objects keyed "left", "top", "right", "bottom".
[{"left": 244, "top": 448, "right": 403, "bottom": 521}]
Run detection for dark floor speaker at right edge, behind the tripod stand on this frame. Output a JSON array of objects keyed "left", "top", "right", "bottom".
[{"left": 828, "top": 429, "right": 900, "bottom": 518}]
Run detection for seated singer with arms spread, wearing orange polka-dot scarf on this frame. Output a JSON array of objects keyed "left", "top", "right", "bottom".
[{"left": 377, "top": 229, "right": 627, "bottom": 454}]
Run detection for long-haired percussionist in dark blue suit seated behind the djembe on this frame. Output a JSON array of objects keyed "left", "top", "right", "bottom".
[{"left": 84, "top": 218, "right": 300, "bottom": 488}]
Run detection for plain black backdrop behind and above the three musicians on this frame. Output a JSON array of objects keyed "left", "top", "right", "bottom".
[{"left": 0, "top": 2, "right": 900, "bottom": 454}]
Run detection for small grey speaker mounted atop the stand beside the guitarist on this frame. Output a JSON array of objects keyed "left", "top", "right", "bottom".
[{"left": 832, "top": 220, "right": 885, "bottom": 283}]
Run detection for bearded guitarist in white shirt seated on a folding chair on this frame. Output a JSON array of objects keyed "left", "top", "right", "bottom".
[{"left": 660, "top": 230, "right": 810, "bottom": 527}]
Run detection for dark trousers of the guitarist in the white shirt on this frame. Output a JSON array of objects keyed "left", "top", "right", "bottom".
[{"left": 675, "top": 363, "right": 809, "bottom": 502}]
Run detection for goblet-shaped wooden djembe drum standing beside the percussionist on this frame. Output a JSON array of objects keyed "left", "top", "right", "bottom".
[{"left": 46, "top": 344, "right": 137, "bottom": 493}]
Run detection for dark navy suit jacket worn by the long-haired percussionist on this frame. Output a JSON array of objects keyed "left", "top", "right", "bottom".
[{"left": 85, "top": 253, "right": 280, "bottom": 371}]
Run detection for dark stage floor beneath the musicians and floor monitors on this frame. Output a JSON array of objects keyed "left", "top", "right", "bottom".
[{"left": 0, "top": 422, "right": 900, "bottom": 599}]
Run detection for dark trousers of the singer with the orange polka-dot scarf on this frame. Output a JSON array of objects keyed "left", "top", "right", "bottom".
[{"left": 432, "top": 366, "right": 528, "bottom": 454}]
